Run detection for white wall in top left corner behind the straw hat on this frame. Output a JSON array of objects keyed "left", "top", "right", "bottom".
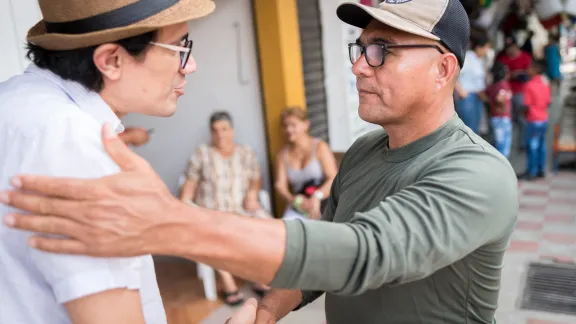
[{"left": 0, "top": 0, "right": 42, "bottom": 82}]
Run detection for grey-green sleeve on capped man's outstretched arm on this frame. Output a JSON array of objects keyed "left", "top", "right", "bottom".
[{"left": 272, "top": 145, "right": 518, "bottom": 295}]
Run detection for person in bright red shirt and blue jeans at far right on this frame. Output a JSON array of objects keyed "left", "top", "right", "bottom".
[{"left": 524, "top": 61, "right": 552, "bottom": 180}]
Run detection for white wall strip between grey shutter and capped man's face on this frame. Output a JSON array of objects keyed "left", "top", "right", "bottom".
[{"left": 320, "top": 0, "right": 378, "bottom": 152}]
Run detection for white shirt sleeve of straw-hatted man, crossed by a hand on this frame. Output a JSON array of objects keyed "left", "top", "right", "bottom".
[{"left": 20, "top": 112, "right": 146, "bottom": 303}]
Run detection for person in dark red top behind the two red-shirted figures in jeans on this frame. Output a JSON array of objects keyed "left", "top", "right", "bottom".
[{"left": 498, "top": 36, "right": 532, "bottom": 149}]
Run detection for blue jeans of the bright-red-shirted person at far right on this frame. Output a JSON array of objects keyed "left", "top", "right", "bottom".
[{"left": 526, "top": 122, "right": 548, "bottom": 176}]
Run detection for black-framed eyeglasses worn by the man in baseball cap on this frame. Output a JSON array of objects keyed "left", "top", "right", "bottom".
[{"left": 348, "top": 43, "right": 445, "bottom": 67}]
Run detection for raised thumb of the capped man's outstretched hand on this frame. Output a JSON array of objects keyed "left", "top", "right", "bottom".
[{"left": 102, "top": 123, "right": 146, "bottom": 171}]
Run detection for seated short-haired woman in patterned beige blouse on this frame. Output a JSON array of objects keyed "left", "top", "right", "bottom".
[{"left": 180, "top": 112, "right": 270, "bottom": 305}]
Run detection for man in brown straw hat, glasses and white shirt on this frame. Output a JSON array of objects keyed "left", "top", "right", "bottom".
[{"left": 0, "top": 0, "right": 215, "bottom": 324}]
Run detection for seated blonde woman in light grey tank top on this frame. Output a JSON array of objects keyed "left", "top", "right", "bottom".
[{"left": 275, "top": 108, "right": 338, "bottom": 219}]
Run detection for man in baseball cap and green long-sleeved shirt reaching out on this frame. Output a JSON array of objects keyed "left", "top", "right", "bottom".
[{"left": 0, "top": 0, "right": 518, "bottom": 324}]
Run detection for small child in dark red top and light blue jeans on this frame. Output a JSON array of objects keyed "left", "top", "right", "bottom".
[{"left": 486, "top": 62, "right": 512, "bottom": 158}]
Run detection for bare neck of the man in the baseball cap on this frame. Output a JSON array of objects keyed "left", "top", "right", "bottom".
[{"left": 384, "top": 102, "right": 455, "bottom": 149}]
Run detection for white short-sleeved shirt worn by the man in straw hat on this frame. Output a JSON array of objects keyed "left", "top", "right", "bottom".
[{"left": 0, "top": 65, "right": 166, "bottom": 324}]
